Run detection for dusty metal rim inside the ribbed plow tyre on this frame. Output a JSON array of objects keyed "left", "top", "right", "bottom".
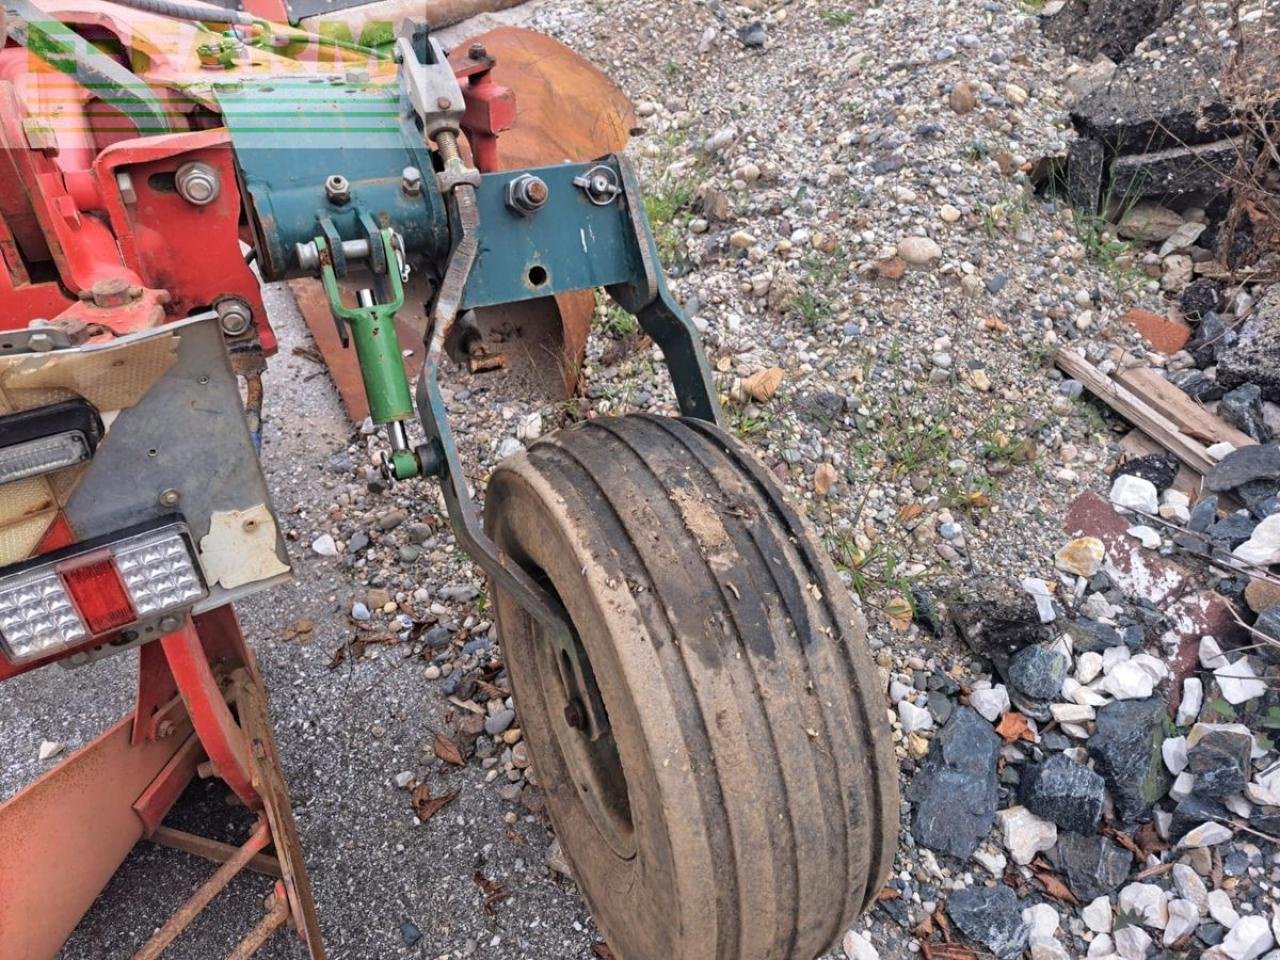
[{"left": 524, "top": 575, "right": 636, "bottom": 860}]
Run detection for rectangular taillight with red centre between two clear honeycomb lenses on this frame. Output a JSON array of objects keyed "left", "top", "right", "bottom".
[{"left": 0, "top": 521, "right": 209, "bottom": 663}]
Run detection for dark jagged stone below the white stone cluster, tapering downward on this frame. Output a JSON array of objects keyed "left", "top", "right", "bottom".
[{"left": 1088, "top": 696, "right": 1172, "bottom": 822}]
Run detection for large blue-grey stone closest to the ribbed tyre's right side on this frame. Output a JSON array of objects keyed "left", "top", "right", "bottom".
[{"left": 906, "top": 707, "right": 1001, "bottom": 860}]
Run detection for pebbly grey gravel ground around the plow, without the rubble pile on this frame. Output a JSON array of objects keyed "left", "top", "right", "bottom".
[{"left": 0, "top": 0, "right": 1249, "bottom": 960}]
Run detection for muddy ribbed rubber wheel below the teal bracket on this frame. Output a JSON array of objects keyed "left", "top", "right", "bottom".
[{"left": 485, "top": 416, "right": 899, "bottom": 960}]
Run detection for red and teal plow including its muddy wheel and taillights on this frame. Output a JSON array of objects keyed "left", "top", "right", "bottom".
[{"left": 0, "top": 0, "right": 899, "bottom": 960}]
